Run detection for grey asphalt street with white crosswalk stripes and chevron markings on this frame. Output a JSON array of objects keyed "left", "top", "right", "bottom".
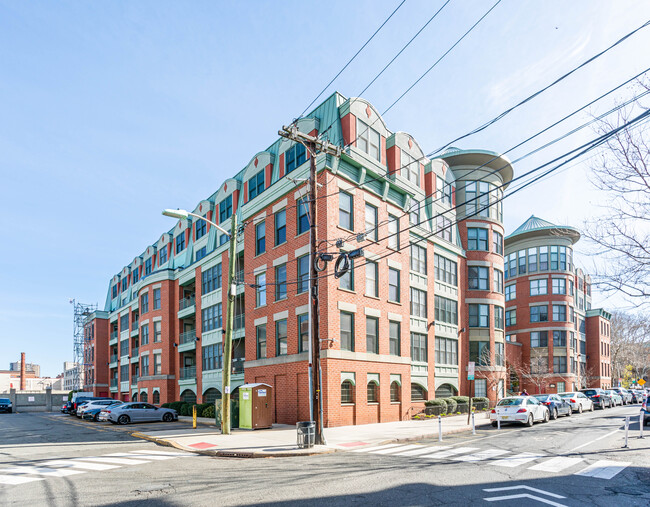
[{"left": 0, "top": 405, "right": 650, "bottom": 507}]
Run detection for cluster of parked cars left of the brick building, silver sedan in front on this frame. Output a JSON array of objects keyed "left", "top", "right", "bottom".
[{"left": 61, "top": 396, "right": 178, "bottom": 424}]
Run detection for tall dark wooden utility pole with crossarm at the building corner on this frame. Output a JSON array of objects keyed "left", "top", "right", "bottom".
[{"left": 278, "top": 125, "right": 341, "bottom": 445}]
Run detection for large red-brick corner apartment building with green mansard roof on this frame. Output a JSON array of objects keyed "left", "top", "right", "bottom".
[{"left": 81, "top": 93, "right": 608, "bottom": 426}]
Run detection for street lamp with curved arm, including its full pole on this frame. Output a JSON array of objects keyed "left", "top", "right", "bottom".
[{"left": 162, "top": 209, "right": 237, "bottom": 435}]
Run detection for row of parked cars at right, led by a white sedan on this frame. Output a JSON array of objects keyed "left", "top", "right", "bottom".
[{"left": 490, "top": 387, "right": 650, "bottom": 427}]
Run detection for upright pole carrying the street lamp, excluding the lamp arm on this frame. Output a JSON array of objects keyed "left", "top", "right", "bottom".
[{"left": 221, "top": 212, "right": 237, "bottom": 435}]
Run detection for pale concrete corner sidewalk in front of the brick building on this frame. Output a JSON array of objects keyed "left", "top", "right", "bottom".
[{"left": 133, "top": 412, "right": 490, "bottom": 458}]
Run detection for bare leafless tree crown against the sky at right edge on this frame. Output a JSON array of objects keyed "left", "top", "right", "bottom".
[{"left": 585, "top": 80, "right": 650, "bottom": 304}]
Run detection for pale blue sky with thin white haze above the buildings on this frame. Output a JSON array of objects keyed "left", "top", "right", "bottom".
[{"left": 0, "top": 0, "right": 650, "bottom": 376}]
